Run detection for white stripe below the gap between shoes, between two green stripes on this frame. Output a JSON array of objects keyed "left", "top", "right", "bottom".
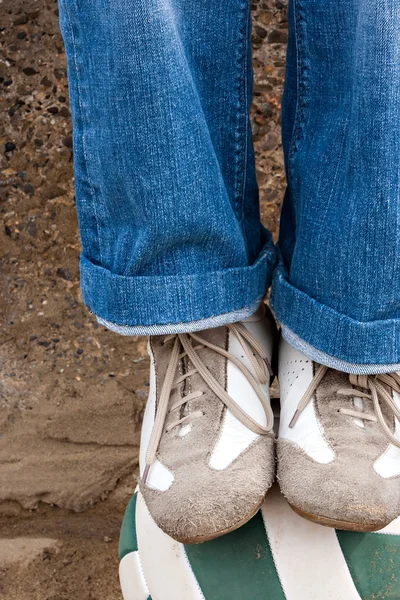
[{"left": 262, "top": 487, "right": 361, "bottom": 600}]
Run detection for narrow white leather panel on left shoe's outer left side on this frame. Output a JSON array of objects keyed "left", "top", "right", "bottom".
[{"left": 139, "top": 344, "right": 174, "bottom": 492}]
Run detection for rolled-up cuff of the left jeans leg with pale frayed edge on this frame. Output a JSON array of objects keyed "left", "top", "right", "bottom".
[{"left": 81, "top": 241, "right": 276, "bottom": 335}]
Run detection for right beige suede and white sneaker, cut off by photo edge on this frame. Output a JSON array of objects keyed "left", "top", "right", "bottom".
[{"left": 277, "top": 340, "right": 400, "bottom": 531}]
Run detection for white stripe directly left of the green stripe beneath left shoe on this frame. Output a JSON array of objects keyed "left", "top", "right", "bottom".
[{"left": 136, "top": 494, "right": 205, "bottom": 600}]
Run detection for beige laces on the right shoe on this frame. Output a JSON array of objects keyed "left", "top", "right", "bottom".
[{"left": 289, "top": 365, "right": 400, "bottom": 448}]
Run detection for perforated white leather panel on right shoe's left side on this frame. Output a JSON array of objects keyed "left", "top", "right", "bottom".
[{"left": 279, "top": 339, "right": 335, "bottom": 464}]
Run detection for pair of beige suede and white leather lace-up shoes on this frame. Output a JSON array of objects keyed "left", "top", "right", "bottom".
[{"left": 139, "top": 305, "right": 400, "bottom": 543}]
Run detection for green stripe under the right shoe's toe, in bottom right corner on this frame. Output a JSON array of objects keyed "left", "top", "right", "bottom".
[{"left": 336, "top": 531, "right": 400, "bottom": 600}]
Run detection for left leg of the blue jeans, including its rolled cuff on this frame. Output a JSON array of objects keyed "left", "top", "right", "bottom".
[{"left": 60, "top": 0, "right": 275, "bottom": 334}]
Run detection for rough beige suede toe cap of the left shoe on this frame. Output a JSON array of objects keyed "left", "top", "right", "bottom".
[{"left": 141, "top": 440, "right": 275, "bottom": 543}]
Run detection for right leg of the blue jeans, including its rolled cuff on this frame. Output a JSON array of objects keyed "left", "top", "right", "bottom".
[{"left": 272, "top": 0, "right": 400, "bottom": 373}]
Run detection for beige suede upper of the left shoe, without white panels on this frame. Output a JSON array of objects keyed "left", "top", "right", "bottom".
[{"left": 140, "top": 318, "right": 275, "bottom": 542}]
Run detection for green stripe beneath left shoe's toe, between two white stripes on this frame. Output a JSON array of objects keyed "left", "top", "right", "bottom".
[{"left": 185, "top": 512, "right": 285, "bottom": 600}]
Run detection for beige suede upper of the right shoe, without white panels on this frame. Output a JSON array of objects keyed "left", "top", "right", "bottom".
[{"left": 277, "top": 369, "right": 400, "bottom": 529}]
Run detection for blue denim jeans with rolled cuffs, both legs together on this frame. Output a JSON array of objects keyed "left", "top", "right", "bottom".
[{"left": 60, "top": 0, "right": 400, "bottom": 373}]
